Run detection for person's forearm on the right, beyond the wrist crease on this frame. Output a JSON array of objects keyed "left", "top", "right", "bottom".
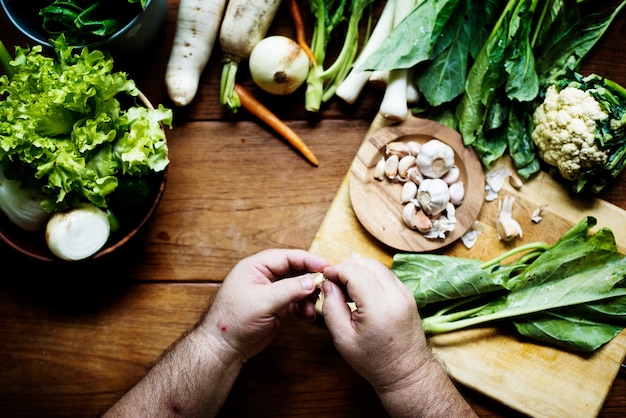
[{"left": 370, "top": 358, "right": 476, "bottom": 418}]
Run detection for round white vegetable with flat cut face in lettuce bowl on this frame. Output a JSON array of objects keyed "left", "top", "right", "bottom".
[{"left": 46, "top": 203, "right": 111, "bottom": 261}]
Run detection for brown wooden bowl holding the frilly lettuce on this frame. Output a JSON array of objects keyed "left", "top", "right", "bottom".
[{"left": 0, "top": 92, "right": 167, "bottom": 262}]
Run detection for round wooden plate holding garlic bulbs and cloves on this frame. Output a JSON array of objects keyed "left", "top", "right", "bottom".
[{"left": 350, "top": 116, "right": 485, "bottom": 252}]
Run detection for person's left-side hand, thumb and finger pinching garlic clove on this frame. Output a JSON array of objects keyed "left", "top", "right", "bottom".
[{"left": 201, "top": 249, "right": 328, "bottom": 362}]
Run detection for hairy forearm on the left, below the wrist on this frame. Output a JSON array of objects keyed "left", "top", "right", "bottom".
[{"left": 105, "top": 328, "right": 242, "bottom": 418}]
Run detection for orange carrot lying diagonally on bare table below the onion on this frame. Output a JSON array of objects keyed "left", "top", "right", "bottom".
[{"left": 235, "top": 83, "right": 319, "bottom": 167}]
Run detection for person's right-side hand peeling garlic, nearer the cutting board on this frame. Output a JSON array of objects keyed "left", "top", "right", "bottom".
[{"left": 322, "top": 258, "right": 433, "bottom": 393}]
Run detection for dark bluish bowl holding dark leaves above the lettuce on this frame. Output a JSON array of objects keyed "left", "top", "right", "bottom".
[{"left": 0, "top": 0, "right": 167, "bottom": 58}]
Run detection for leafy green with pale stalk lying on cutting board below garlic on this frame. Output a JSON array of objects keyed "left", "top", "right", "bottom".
[{"left": 391, "top": 217, "right": 626, "bottom": 352}]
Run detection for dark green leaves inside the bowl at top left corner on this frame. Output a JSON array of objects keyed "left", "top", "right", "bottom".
[{"left": 39, "top": 0, "right": 147, "bottom": 45}]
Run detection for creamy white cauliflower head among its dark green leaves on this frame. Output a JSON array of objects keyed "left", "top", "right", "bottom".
[{"left": 532, "top": 86, "right": 609, "bottom": 180}]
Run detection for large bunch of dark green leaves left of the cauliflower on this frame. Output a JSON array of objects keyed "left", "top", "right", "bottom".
[{"left": 361, "top": 0, "right": 626, "bottom": 183}]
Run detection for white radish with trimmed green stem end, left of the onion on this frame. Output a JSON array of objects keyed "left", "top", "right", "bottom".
[{"left": 219, "top": 0, "right": 281, "bottom": 112}]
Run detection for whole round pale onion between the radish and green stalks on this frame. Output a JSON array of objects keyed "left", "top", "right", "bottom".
[{"left": 248, "top": 35, "right": 309, "bottom": 95}]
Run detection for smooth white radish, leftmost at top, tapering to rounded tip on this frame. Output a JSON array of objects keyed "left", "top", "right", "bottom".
[{"left": 165, "top": 0, "right": 227, "bottom": 107}]
